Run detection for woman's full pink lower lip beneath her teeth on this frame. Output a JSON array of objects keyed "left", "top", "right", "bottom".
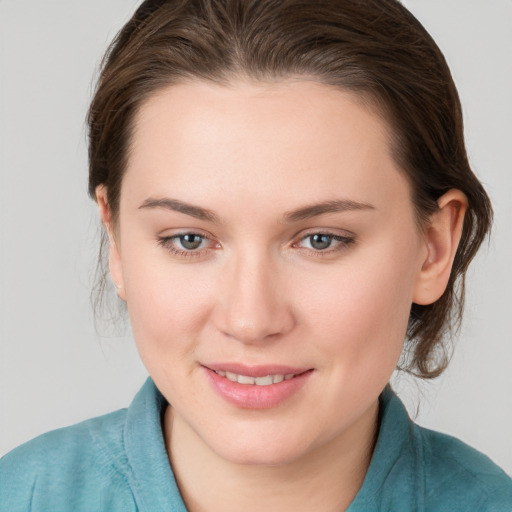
[{"left": 203, "top": 367, "right": 313, "bottom": 409}]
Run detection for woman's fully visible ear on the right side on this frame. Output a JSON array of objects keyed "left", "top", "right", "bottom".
[{"left": 413, "top": 189, "right": 468, "bottom": 305}]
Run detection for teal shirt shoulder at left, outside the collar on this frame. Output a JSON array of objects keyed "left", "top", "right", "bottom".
[{"left": 0, "top": 410, "right": 136, "bottom": 511}]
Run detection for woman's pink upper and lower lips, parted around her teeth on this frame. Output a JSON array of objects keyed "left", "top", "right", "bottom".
[{"left": 202, "top": 363, "right": 314, "bottom": 409}]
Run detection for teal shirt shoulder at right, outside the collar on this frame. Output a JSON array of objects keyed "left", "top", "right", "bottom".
[{"left": 416, "top": 427, "right": 512, "bottom": 511}]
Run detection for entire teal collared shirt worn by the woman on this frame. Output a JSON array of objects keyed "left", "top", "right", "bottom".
[{"left": 0, "top": 379, "right": 512, "bottom": 512}]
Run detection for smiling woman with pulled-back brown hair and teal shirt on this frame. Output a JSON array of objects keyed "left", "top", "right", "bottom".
[{"left": 0, "top": 0, "right": 512, "bottom": 511}]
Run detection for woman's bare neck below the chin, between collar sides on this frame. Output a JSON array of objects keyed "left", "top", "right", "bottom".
[{"left": 164, "top": 402, "right": 378, "bottom": 512}]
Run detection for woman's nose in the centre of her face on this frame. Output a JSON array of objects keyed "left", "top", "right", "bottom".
[{"left": 215, "top": 251, "right": 295, "bottom": 344}]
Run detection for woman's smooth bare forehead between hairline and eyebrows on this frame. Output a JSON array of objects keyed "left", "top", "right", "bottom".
[{"left": 123, "top": 80, "right": 412, "bottom": 216}]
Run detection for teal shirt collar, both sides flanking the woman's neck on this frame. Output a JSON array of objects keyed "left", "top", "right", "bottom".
[{"left": 124, "top": 378, "right": 425, "bottom": 512}]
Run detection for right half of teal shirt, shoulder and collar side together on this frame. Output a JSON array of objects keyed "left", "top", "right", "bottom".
[{"left": 360, "top": 387, "right": 512, "bottom": 512}]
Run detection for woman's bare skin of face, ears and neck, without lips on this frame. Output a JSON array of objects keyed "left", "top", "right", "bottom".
[{"left": 97, "top": 80, "right": 467, "bottom": 512}]
